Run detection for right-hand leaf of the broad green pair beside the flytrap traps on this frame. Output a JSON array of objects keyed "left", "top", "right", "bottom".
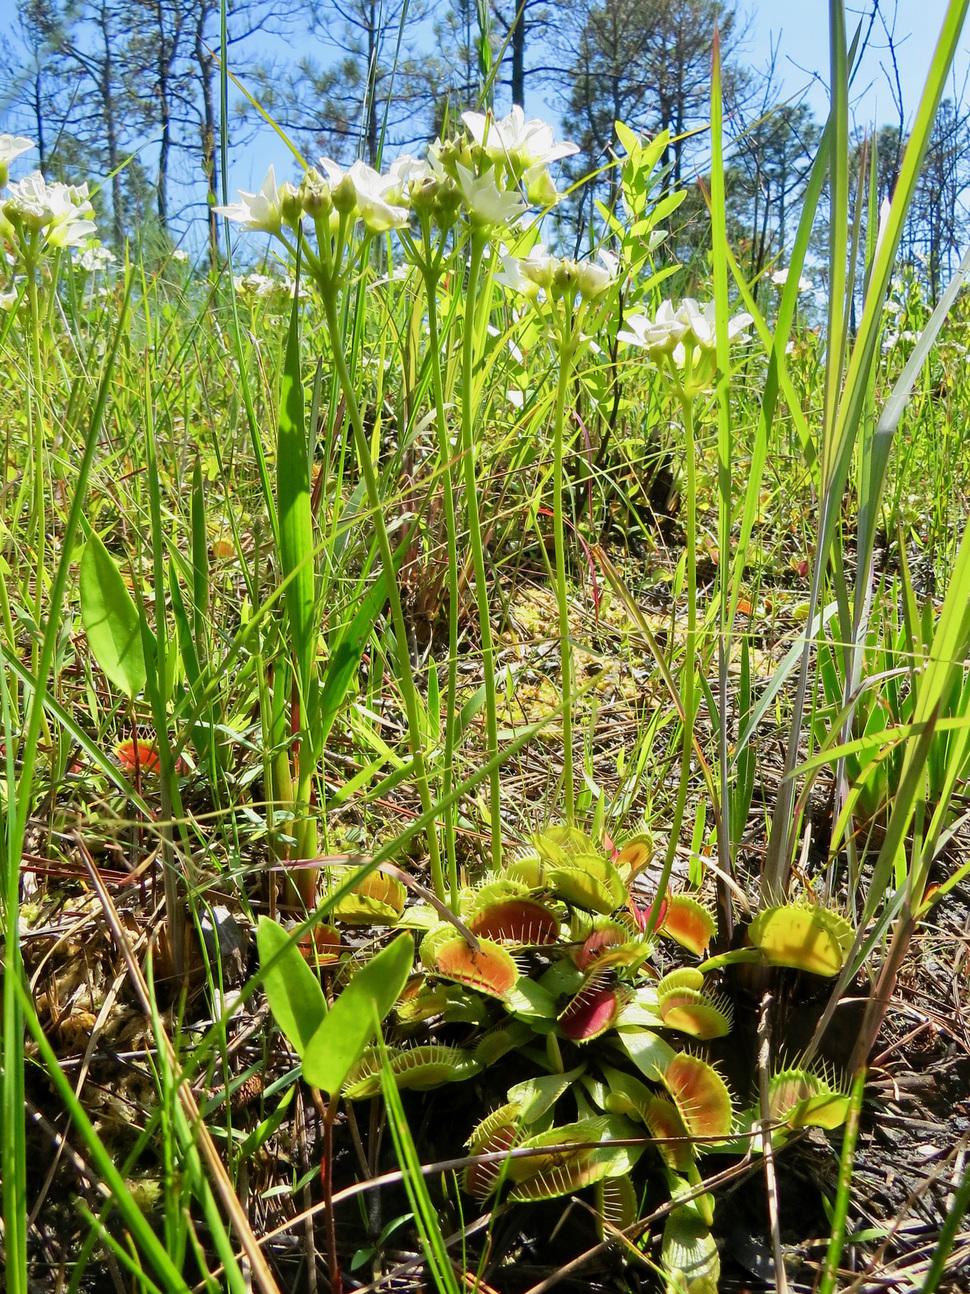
[{"left": 303, "top": 934, "right": 414, "bottom": 1096}]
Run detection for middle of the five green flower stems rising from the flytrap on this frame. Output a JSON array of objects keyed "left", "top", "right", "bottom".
[{"left": 462, "top": 229, "right": 502, "bottom": 868}]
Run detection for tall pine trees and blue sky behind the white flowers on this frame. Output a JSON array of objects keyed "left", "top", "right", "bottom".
[{"left": 0, "top": 0, "right": 970, "bottom": 299}]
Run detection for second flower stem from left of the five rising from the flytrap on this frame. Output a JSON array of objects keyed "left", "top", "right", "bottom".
[{"left": 423, "top": 225, "right": 460, "bottom": 907}]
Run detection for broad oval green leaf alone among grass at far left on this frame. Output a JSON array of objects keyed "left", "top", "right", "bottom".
[{"left": 80, "top": 531, "right": 154, "bottom": 697}]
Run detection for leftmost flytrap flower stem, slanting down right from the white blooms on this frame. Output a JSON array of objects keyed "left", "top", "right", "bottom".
[{"left": 321, "top": 283, "right": 445, "bottom": 899}]
